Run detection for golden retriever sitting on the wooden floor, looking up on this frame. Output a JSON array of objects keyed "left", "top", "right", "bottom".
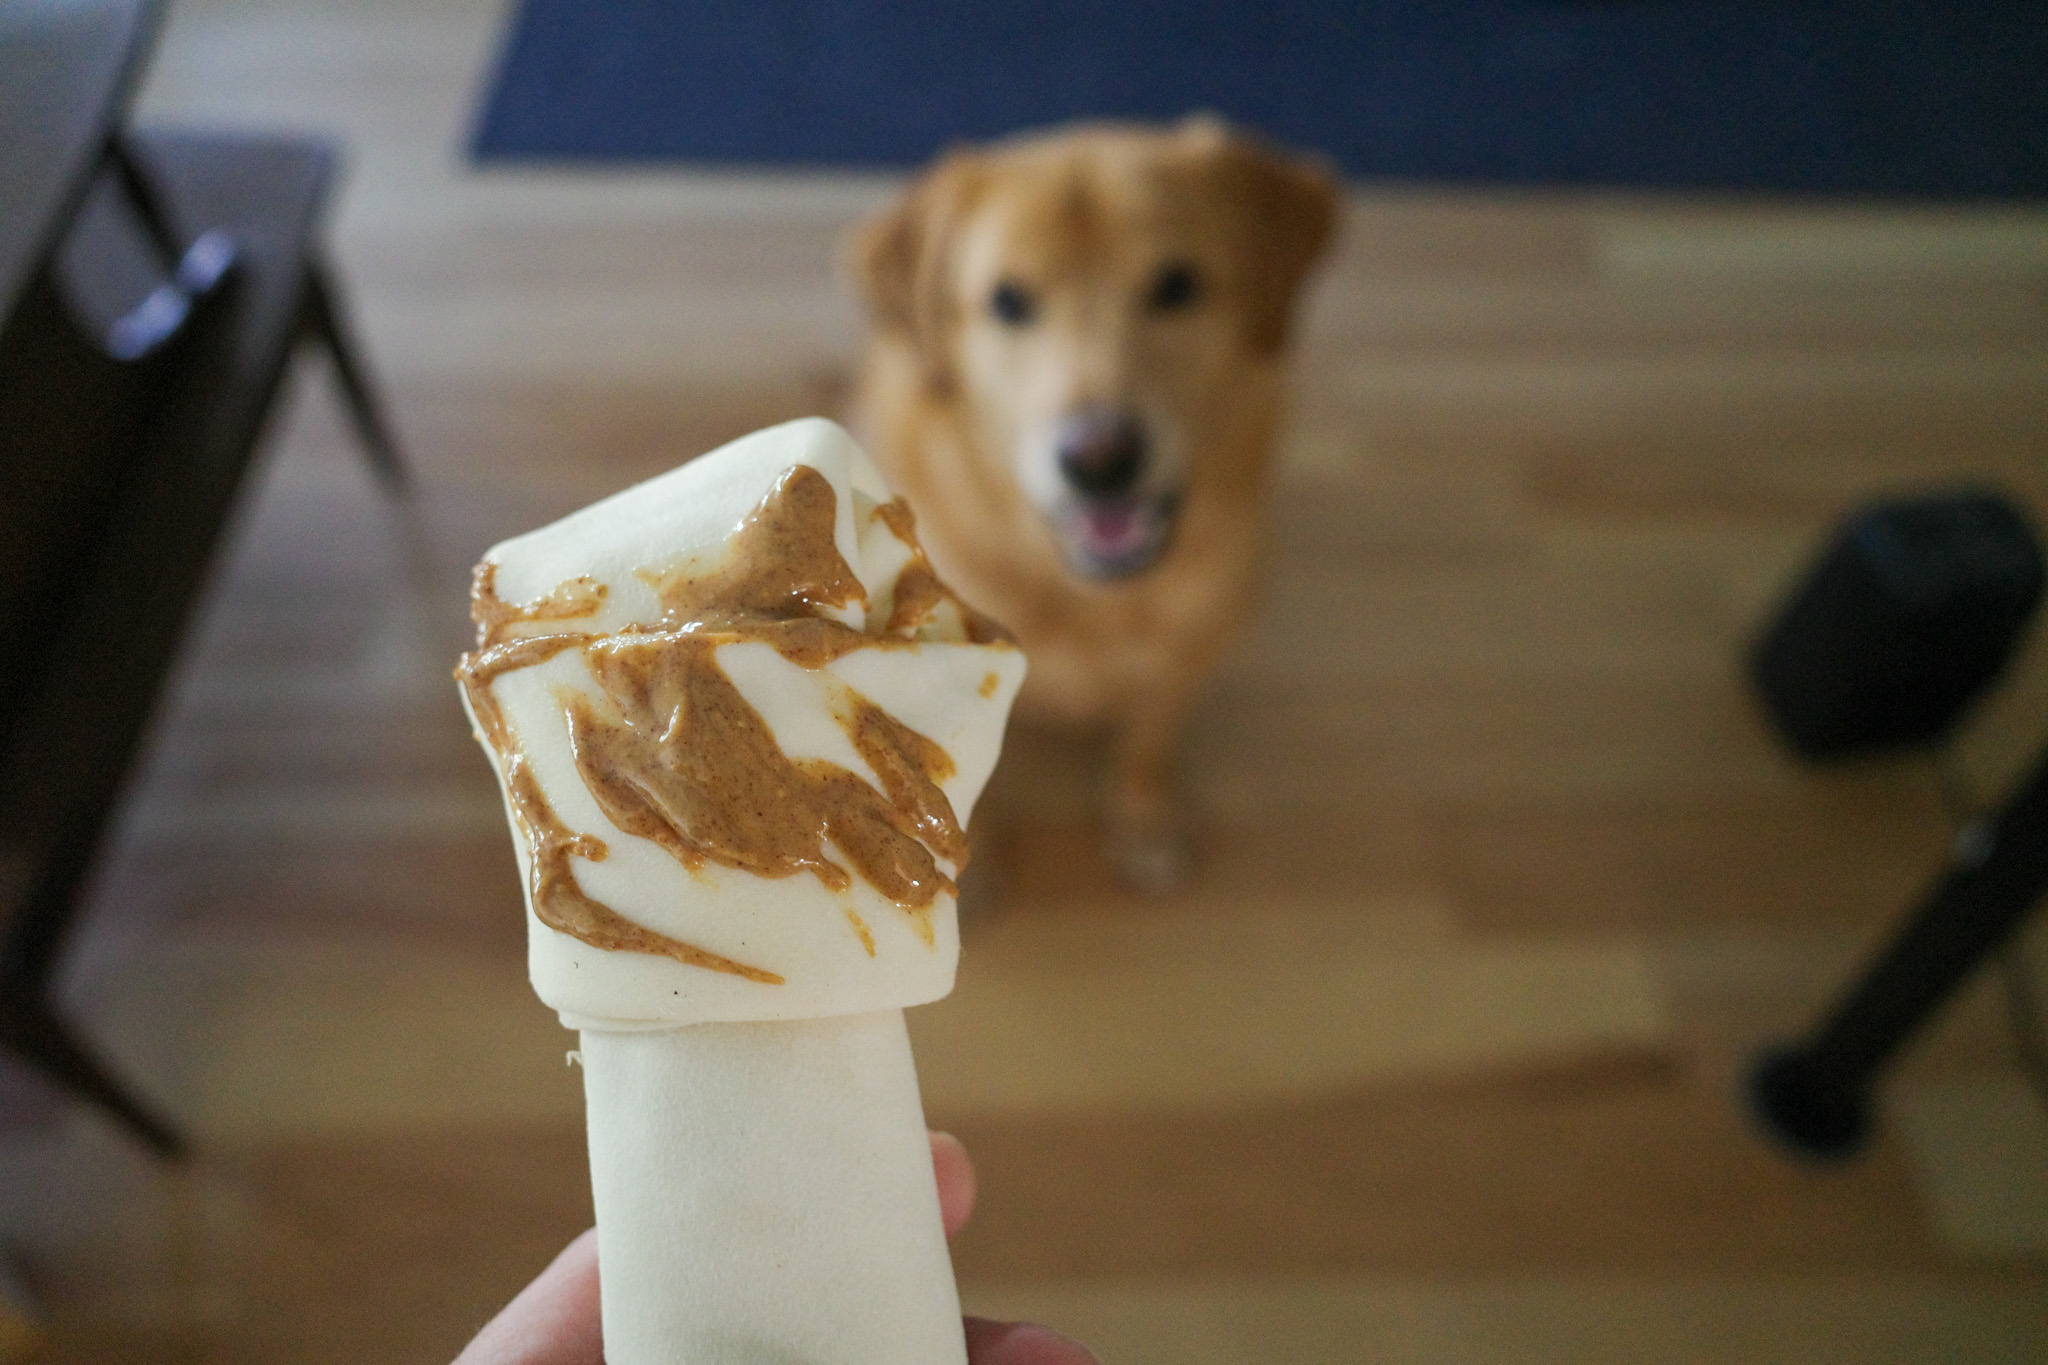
[{"left": 850, "top": 117, "right": 1337, "bottom": 888}]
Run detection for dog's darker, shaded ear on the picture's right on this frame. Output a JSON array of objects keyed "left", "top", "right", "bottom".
[{"left": 1182, "top": 115, "right": 1339, "bottom": 356}]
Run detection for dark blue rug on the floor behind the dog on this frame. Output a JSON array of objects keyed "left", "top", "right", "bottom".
[{"left": 473, "top": 0, "right": 2048, "bottom": 199}]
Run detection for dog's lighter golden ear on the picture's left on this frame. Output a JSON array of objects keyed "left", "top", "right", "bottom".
[{"left": 846, "top": 151, "right": 981, "bottom": 391}]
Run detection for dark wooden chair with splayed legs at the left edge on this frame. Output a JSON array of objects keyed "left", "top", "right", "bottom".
[{"left": 0, "top": 6, "right": 406, "bottom": 1154}]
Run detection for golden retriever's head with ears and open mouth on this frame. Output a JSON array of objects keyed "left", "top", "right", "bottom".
[{"left": 854, "top": 121, "right": 1335, "bottom": 579}]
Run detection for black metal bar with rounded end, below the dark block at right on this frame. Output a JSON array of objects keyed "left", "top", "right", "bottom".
[{"left": 1749, "top": 751, "right": 2048, "bottom": 1158}]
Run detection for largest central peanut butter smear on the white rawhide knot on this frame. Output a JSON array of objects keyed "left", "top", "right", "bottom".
[{"left": 567, "top": 465, "right": 967, "bottom": 915}]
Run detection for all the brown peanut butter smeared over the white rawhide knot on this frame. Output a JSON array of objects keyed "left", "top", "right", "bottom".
[{"left": 457, "top": 465, "right": 1010, "bottom": 984}]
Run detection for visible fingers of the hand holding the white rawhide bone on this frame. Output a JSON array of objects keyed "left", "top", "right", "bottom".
[{"left": 455, "top": 1134, "right": 1096, "bottom": 1365}]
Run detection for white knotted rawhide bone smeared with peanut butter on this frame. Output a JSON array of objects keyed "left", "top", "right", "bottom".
[{"left": 457, "top": 420, "right": 1024, "bottom": 1365}]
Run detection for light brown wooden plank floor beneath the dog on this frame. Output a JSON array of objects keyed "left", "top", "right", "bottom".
[{"left": 0, "top": 0, "right": 2048, "bottom": 1365}]
